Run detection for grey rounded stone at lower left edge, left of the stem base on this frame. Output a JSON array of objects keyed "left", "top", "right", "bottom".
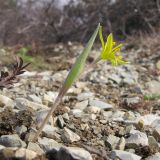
[{"left": 0, "top": 134, "right": 26, "bottom": 147}]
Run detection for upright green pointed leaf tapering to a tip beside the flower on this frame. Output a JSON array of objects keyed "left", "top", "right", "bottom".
[{"left": 62, "top": 24, "right": 100, "bottom": 92}]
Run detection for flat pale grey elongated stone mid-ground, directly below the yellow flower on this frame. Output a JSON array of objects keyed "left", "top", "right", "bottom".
[{"left": 89, "top": 100, "right": 113, "bottom": 110}]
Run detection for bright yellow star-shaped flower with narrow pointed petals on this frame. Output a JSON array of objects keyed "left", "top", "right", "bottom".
[{"left": 99, "top": 27, "right": 129, "bottom": 66}]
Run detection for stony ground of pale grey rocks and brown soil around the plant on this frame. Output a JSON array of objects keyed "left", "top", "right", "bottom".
[{"left": 0, "top": 44, "right": 160, "bottom": 160}]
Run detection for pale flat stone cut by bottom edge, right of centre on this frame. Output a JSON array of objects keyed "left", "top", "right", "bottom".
[{"left": 111, "top": 150, "right": 141, "bottom": 160}]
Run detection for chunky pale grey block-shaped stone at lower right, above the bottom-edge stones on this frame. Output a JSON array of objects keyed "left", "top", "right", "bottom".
[{"left": 126, "top": 131, "right": 148, "bottom": 148}]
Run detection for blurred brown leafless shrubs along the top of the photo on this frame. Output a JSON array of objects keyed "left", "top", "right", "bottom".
[{"left": 0, "top": 0, "right": 160, "bottom": 45}]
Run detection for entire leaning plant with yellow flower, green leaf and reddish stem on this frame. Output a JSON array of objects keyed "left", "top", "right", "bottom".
[{"left": 33, "top": 24, "right": 129, "bottom": 141}]
